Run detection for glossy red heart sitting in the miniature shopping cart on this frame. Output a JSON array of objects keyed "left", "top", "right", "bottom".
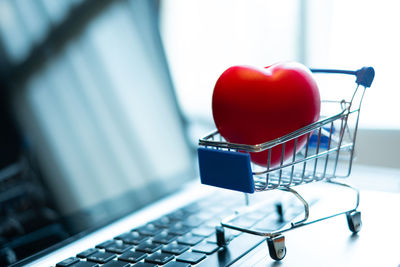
[{"left": 212, "top": 62, "right": 321, "bottom": 167}]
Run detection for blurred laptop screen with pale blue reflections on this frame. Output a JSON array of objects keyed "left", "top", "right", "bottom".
[{"left": 1, "top": 1, "right": 195, "bottom": 264}]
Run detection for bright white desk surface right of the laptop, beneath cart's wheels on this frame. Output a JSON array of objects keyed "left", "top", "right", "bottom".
[{"left": 237, "top": 164, "right": 400, "bottom": 267}]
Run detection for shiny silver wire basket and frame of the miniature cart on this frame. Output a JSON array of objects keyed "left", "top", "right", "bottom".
[{"left": 199, "top": 68, "right": 373, "bottom": 247}]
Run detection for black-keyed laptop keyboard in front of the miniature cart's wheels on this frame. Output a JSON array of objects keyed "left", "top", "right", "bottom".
[{"left": 56, "top": 194, "right": 310, "bottom": 267}]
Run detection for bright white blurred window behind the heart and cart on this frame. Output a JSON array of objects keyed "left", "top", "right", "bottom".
[{"left": 161, "top": 0, "right": 400, "bottom": 129}]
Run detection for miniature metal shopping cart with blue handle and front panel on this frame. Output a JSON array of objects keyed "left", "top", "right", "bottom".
[{"left": 198, "top": 67, "right": 375, "bottom": 260}]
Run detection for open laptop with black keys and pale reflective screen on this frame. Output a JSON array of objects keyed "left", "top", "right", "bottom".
[{"left": 1, "top": 1, "right": 397, "bottom": 267}]
